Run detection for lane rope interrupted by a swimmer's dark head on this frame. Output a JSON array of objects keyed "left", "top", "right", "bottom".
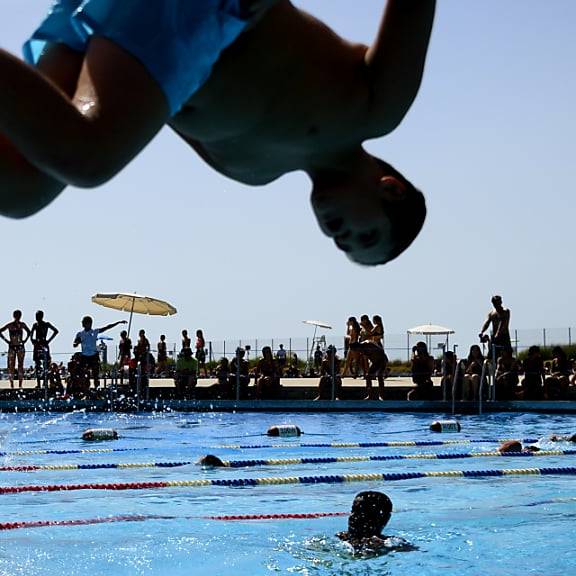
[{"left": 0, "top": 450, "right": 576, "bottom": 472}]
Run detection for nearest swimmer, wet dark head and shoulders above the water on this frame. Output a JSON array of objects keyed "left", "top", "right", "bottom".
[{"left": 336, "top": 491, "right": 415, "bottom": 554}]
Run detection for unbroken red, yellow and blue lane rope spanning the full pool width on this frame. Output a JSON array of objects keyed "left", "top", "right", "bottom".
[{"left": 0, "top": 466, "right": 576, "bottom": 494}]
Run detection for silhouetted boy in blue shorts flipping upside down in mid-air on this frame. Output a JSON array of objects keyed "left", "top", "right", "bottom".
[{"left": 0, "top": 0, "right": 436, "bottom": 265}]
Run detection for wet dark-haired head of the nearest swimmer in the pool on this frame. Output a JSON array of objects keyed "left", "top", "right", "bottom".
[{"left": 348, "top": 491, "right": 392, "bottom": 539}]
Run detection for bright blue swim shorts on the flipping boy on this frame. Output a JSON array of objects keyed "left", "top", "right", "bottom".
[{"left": 24, "top": 0, "right": 247, "bottom": 115}]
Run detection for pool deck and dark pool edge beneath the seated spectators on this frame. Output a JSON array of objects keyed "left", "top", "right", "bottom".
[{"left": 0, "top": 377, "right": 576, "bottom": 414}]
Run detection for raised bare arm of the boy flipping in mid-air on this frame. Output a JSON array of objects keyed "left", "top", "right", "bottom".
[{"left": 366, "top": 0, "right": 436, "bottom": 131}]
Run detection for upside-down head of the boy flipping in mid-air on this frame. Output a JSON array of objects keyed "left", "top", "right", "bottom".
[{"left": 312, "top": 152, "right": 426, "bottom": 266}]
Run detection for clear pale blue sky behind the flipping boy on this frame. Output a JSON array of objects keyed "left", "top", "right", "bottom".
[{"left": 0, "top": 0, "right": 576, "bottom": 360}]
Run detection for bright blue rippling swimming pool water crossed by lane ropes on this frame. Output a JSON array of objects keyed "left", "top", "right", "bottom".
[{"left": 0, "top": 412, "right": 576, "bottom": 576}]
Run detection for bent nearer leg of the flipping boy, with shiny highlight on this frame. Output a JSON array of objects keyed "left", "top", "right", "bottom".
[{"left": 0, "top": 37, "right": 169, "bottom": 194}]
